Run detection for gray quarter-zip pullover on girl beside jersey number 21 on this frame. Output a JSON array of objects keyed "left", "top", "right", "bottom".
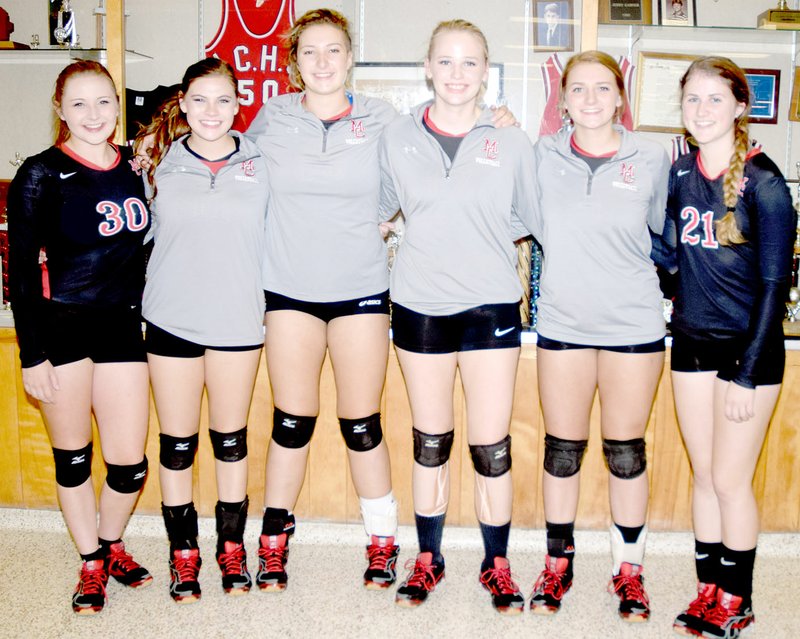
[{"left": 534, "top": 127, "right": 669, "bottom": 346}]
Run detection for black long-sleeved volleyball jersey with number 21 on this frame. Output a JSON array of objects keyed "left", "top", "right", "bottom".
[{"left": 661, "top": 150, "right": 797, "bottom": 388}]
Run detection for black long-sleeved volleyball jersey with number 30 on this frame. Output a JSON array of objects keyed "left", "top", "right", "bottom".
[{"left": 8, "top": 147, "right": 150, "bottom": 367}]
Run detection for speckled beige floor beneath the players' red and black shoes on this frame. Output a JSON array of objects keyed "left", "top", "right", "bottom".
[{"left": 0, "top": 509, "right": 800, "bottom": 639}]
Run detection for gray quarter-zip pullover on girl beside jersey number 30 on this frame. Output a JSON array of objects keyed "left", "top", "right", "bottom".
[{"left": 142, "top": 131, "right": 268, "bottom": 346}]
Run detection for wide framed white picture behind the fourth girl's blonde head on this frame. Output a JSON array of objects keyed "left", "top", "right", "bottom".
[{"left": 352, "top": 62, "right": 504, "bottom": 113}]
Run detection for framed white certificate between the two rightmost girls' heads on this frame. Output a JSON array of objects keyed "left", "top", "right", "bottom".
[{"left": 633, "top": 51, "right": 697, "bottom": 133}]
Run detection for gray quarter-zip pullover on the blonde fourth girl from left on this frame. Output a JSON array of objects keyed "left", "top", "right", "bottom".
[{"left": 381, "top": 104, "right": 538, "bottom": 315}]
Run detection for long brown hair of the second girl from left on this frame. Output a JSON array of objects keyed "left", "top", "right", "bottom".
[{"left": 134, "top": 58, "right": 239, "bottom": 199}]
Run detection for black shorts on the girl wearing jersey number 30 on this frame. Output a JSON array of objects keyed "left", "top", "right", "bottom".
[{"left": 42, "top": 301, "right": 147, "bottom": 366}]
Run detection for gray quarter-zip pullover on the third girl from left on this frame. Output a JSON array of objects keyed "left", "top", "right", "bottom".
[{"left": 247, "top": 93, "right": 397, "bottom": 302}]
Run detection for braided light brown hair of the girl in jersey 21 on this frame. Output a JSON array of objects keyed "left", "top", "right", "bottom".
[{"left": 681, "top": 56, "right": 750, "bottom": 245}]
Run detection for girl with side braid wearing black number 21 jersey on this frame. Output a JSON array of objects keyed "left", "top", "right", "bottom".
[{"left": 657, "top": 57, "right": 797, "bottom": 638}]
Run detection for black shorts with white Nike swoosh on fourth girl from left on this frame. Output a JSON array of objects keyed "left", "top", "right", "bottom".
[{"left": 392, "top": 302, "right": 522, "bottom": 354}]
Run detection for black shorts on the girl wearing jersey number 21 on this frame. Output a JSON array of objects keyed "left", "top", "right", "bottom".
[{"left": 670, "top": 332, "right": 786, "bottom": 386}]
